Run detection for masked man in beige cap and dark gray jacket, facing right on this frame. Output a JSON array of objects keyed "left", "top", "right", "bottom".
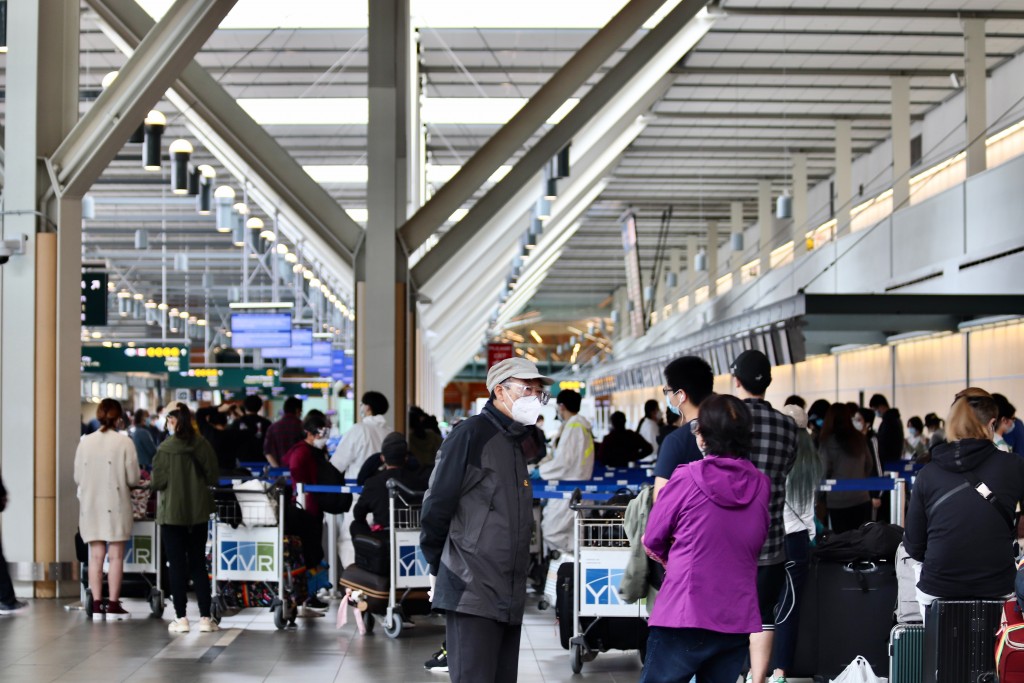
[{"left": 420, "top": 357, "right": 552, "bottom": 683}]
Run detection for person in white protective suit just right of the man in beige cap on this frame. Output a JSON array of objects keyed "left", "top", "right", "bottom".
[{"left": 540, "top": 389, "right": 594, "bottom": 553}]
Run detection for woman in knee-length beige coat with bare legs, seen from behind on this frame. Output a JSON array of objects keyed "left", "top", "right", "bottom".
[{"left": 75, "top": 398, "right": 139, "bottom": 621}]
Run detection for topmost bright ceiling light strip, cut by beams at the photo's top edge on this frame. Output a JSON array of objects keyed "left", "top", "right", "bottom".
[{"left": 138, "top": 0, "right": 679, "bottom": 30}]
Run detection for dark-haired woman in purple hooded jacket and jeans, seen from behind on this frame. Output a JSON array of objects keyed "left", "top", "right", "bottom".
[{"left": 640, "top": 395, "right": 770, "bottom": 683}]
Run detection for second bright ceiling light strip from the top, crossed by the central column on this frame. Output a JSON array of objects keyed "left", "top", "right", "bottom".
[{"left": 238, "top": 97, "right": 580, "bottom": 126}]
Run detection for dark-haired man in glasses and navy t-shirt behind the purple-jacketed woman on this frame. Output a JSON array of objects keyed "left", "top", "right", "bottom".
[{"left": 654, "top": 355, "right": 715, "bottom": 500}]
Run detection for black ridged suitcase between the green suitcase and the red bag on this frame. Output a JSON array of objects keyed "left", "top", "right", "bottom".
[{"left": 924, "top": 600, "right": 1004, "bottom": 683}]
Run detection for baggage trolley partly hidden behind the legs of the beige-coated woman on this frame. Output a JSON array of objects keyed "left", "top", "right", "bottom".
[{"left": 82, "top": 484, "right": 165, "bottom": 618}]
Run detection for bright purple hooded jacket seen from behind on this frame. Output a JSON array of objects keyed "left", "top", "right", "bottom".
[{"left": 643, "top": 456, "right": 770, "bottom": 633}]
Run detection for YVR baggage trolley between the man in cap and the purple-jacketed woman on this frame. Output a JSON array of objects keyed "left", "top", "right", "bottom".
[{"left": 569, "top": 489, "right": 647, "bottom": 674}]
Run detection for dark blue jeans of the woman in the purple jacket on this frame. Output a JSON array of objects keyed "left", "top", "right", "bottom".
[{"left": 640, "top": 626, "right": 750, "bottom": 683}]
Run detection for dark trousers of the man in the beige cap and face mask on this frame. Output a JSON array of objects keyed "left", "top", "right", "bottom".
[{"left": 445, "top": 611, "right": 522, "bottom": 683}]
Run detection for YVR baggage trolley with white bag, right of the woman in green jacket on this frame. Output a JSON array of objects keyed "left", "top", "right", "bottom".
[{"left": 210, "top": 489, "right": 298, "bottom": 629}]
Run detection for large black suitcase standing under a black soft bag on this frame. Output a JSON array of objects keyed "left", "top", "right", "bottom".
[{"left": 786, "top": 561, "right": 892, "bottom": 683}]
